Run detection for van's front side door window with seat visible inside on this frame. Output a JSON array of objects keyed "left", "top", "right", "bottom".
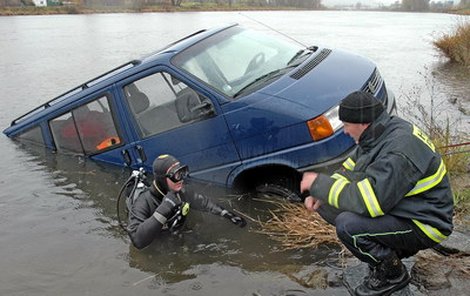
[{"left": 123, "top": 72, "right": 208, "bottom": 137}]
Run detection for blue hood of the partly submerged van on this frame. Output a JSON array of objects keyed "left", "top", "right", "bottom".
[{"left": 259, "top": 49, "right": 375, "bottom": 116}]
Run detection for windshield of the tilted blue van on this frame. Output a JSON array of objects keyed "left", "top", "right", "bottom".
[{"left": 172, "top": 27, "right": 302, "bottom": 98}]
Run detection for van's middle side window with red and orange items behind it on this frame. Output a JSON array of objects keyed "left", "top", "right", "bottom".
[{"left": 50, "top": 96, "right": 121, "bottom": 154}]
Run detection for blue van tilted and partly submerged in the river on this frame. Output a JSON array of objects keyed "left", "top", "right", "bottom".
[{"left": 4, "top": 24, "right": 396, "bottom": 196}]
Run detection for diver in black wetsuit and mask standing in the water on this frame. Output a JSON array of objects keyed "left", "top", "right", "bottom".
[{"left": 126, "top": 154, "right": 246, "bottom": 249}]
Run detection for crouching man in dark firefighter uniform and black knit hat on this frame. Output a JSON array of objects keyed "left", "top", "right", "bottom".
[{"left": 300, "top": 92, "right": 453, "bottom": 295}]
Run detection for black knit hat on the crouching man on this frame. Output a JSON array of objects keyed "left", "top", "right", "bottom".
[{"left": 339, "top": 91, "right": 384, "bottom": 123}]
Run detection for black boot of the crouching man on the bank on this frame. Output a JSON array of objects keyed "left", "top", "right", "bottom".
[{"left": 355, "top": 255, "right": 411, "bottom": 296}]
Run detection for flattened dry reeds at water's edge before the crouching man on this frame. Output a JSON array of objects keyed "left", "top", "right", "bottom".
[{"left": 250, "top": 199, "right": 339, "bottom": 250}]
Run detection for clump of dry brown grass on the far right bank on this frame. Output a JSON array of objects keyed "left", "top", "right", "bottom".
[{"left": 433, "top": 22, "right": 470, "bottom": 67}]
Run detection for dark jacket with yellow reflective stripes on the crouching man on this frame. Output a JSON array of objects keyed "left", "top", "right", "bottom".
[{"left": 310, "top": 112, "right": 453, "bottom": 242}]
